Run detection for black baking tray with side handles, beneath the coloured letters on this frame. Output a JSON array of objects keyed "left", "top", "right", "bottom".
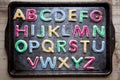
[{"left": 5, "top": 2, "right": 115, "bottom": 77}]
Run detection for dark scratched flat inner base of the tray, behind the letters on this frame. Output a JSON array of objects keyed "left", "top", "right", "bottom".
[{"left": 12, "top": 7, "right": 107, "bottom": 73}]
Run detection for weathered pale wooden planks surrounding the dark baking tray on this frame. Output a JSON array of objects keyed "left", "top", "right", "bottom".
[{"left": 0, "top": 0, "right": 120, "bottom": 80}]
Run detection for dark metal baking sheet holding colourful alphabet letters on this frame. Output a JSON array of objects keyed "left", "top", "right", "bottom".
[{"left": 5, "top": 2, "right": 115, "bottom": 76}]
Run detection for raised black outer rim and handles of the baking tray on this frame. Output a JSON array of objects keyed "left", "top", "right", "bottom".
[{"left": 5, "top": 1, "right": 115, "bottom": 77}]
